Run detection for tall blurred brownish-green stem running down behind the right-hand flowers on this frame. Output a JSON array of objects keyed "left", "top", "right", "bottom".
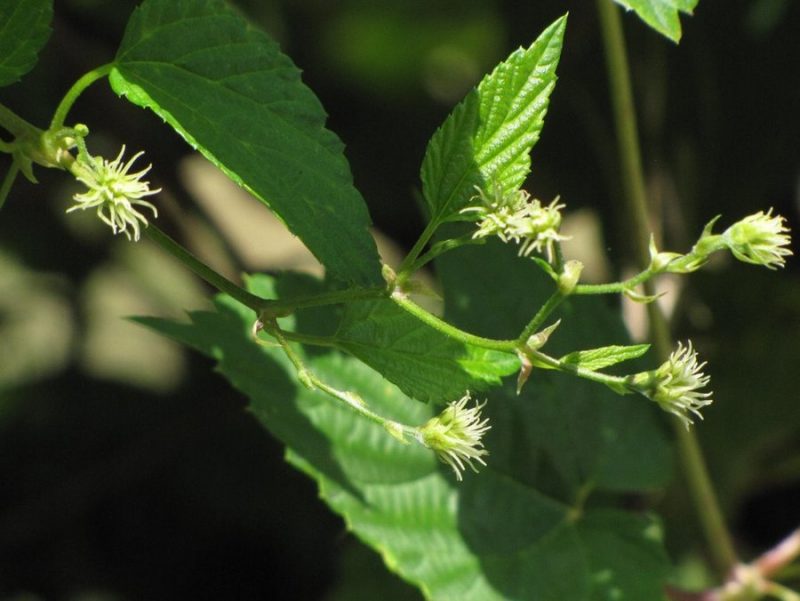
[{"left": 597, "top": 0, "right": 737, "bottom": 577}]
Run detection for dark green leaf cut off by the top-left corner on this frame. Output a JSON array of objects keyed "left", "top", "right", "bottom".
[{"left": 0, "top": 0, "right": 53, "bottom": 86}]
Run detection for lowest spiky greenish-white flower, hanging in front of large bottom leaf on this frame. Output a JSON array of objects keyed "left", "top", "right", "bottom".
[{"left": 417, "top": 393, "right": 491, "bottom": 480}]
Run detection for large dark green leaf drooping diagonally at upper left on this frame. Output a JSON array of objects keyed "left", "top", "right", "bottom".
[{"left": 110, "top": 0, "right": 382, "bottom": 285}]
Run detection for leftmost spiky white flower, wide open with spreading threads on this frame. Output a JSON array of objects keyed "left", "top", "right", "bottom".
[{"left": 67, "top": 145, "right": 161, "bottom": 241}]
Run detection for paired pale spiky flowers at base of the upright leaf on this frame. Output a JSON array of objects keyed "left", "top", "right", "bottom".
[{"left": 461, "top": 183, "right": 566, "bottom": 261}]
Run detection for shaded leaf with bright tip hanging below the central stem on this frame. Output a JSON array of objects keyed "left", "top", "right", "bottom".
[{"left": 334, "top": 299, "right": 519, "bottom": 403}]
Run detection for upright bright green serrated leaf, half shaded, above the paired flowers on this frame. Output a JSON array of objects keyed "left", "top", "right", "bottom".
[{"left": 421, "top": 17, "right": 566, "bottom": 223}]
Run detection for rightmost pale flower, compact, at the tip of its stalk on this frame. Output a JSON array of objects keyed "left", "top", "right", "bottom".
[{"left": 722, "top": 209, "right": 792, "bottom": 269}]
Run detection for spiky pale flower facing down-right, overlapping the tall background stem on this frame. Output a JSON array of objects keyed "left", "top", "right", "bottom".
[{"left": 631, "top": 342, "right": 712, "bottom": 429}]
